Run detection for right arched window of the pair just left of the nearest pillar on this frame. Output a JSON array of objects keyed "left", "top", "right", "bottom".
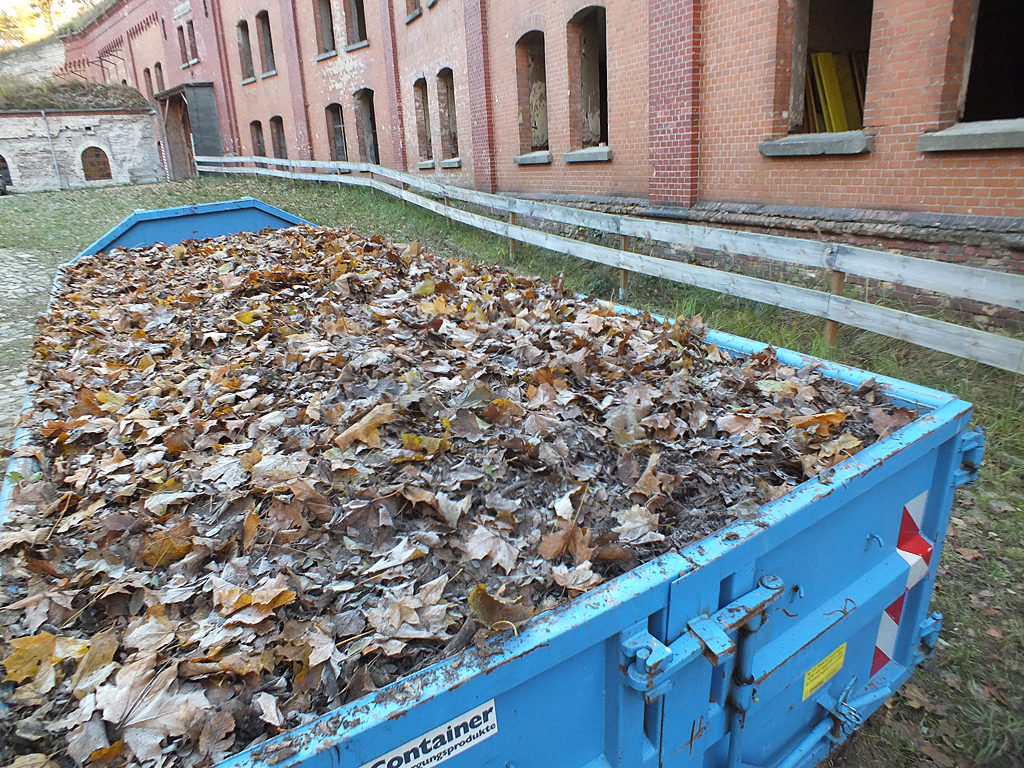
[{"left": 567, "top": 5, "right": 608, "bottom": 146}]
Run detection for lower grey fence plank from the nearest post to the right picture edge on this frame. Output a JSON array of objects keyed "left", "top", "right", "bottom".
[{"left": 827, "top": 296, "right": 1024, "bottom": 374}]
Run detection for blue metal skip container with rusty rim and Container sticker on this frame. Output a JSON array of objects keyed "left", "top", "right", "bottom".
[{"left": 0, "top": 198, "right": 984, "bottom": 768}]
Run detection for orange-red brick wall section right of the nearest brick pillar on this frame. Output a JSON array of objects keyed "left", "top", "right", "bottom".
[{"left": 698, "top": 0, "right": 1024, "bottom": 217}]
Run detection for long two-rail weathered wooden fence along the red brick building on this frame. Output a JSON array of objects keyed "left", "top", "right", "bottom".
[{"left": 196, "top": 157, "right": 1024, "bottom": 374}]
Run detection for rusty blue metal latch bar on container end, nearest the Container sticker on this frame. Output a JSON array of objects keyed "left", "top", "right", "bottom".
[{"left": 622, "top": 575, "right": 784, "bottom": 701}]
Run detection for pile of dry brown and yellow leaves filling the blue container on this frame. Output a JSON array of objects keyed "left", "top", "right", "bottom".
[{"left": 0, "top": 227, "right": 912, "bottom": 766}]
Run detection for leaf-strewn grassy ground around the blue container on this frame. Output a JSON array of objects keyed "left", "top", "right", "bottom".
[{"left": 0, "top": 178, "right": 1024, "bottom": 768}]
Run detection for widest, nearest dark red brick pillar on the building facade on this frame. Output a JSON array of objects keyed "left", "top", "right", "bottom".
[{"left": 647, "top": 0, "right": 700, "bottom": 207}]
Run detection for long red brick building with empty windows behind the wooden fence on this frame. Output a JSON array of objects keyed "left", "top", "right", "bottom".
[{"left": 58, "top": 0, "right": 1024, "bottom": 268}]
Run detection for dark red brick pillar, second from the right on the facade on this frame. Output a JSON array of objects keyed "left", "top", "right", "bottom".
[{"left": 463, "top": 0, "right": 496, "bottom": 193}]
